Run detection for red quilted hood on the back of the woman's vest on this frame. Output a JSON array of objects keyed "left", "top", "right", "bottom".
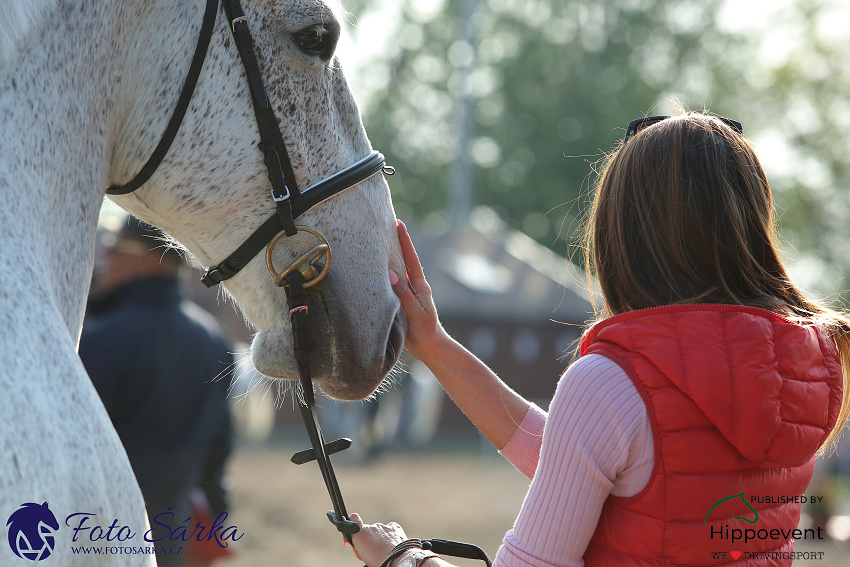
[{"left": 581, "top": 305, "right": 842, "bottom": 466}]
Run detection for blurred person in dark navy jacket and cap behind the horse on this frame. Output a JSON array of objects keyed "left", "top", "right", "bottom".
[{"left": 80, "top": 216, "right": 233, "bottom": 567}]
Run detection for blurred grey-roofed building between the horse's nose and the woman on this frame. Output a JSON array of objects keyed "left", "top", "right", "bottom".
[{"left": 410, "top": 214, "right": 593, "bottom": 432}]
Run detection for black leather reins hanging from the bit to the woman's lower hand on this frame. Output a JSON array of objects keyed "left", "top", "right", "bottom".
[{"left": 283, "top": 270, "right": 491, "bottom": 567}]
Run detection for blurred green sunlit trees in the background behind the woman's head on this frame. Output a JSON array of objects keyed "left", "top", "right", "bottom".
[{"left": 348, "top": 0, "right": 850, "bottom": 298}]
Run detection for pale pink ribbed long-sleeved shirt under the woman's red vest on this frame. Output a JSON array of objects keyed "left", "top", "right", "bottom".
[{"left": 493, "top": 355, "right": 654, "bottom": 567}]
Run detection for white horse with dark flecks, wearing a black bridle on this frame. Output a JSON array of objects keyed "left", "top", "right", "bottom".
[{"left": 0, "top": 0, "right": 405, "bottom": 565}]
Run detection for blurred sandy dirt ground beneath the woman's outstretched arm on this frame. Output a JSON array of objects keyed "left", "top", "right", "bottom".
[{"left": 210, "top": 440, "right": 850, "bottom": 567}]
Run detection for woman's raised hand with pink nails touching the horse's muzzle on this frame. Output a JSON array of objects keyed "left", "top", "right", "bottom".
[{"left": 389, "top": 221, "right": 448, "bottom": 364}]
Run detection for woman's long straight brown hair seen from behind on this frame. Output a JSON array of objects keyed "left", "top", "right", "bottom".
[{"left": 585, "top": 108, "right": 850, "bottom": 447}]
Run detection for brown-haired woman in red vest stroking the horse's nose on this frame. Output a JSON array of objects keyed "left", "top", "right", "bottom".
[{"left": 354, "top": 113, "right": 850, "bottom": 567}]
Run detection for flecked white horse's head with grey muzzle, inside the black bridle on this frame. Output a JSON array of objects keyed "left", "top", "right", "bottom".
[{"left": 110, "top": 0, "right": 405, "bottom": 399}]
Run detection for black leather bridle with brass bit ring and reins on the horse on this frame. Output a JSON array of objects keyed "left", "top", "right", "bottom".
[{"left": 106, "top": 0, "right": 490, "bottom": 566}]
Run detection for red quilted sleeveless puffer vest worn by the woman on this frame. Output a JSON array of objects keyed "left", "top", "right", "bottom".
[{"left": 581, "top": 305, "right": 842, "bottom": 567}]
